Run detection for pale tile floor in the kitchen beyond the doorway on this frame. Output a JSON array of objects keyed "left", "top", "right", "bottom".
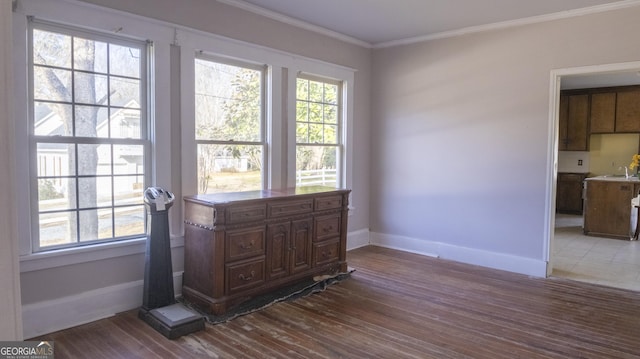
[{"left": 551, "top": 214, "right": 640, "bottom": 291}]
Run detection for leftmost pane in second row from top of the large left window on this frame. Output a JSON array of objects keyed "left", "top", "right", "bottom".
[{"left": 33, "top": 66, "right": 71, "bottom": 102}]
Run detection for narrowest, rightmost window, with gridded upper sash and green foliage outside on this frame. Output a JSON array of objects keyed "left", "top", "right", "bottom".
[{"left": 296, "top": 75, "right": 342, "bottom": 187}]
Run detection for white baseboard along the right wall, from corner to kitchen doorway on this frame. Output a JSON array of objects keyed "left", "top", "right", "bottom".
[{"left": 370, "top": 232, "right": 547, "bottom": 277}]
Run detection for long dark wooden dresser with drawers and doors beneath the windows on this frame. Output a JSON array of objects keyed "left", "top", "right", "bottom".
[{"left": 182, "top": 187, "right": 350, "bottom": 314}]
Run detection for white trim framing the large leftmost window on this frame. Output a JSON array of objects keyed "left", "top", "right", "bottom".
[{"left": 13, "top": 0, "right": 174, "bottom": 272}]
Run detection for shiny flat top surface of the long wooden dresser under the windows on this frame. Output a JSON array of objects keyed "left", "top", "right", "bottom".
[{"left": 184, "top": 186, "right": 350, "bottom": 204}]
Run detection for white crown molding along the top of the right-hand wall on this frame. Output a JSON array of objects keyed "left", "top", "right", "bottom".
[{"left": 373, "top": 0, "right": 640, "bottom": 49}]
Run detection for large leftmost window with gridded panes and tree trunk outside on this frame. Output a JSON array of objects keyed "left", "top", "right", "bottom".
[{"left": 29, "top": 22, "right": 150, "bottom": 251}]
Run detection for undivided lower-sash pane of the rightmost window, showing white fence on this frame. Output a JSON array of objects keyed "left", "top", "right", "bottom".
[{"left": 296, "top": 146, "right": 338, "bottom": 187}]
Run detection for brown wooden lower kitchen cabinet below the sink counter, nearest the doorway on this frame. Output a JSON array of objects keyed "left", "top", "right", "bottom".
[{"left": 584, "top": 177, "right": 640, "bottom": 239}]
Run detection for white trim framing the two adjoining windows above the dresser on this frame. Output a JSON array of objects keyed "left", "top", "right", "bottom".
[{"left": 176, "top": 28, "right": 355, "bottom": 200}]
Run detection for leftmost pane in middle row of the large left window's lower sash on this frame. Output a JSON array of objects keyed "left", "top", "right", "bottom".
[{"left": 38, "top": 177, "right": 76, "bottom": 212}]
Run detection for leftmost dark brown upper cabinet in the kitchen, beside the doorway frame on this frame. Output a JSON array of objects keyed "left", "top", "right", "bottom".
[{"left": 558, "top": 94, "right": 589, "bottom": 151}]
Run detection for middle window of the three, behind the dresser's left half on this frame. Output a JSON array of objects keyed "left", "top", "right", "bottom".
[{"left": 195, "top": 58, "right": 265, "bottom": 193}]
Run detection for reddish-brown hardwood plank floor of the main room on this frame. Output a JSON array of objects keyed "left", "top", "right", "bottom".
[{"left": 33, "top": 246, "right": 640, "bottom": 359}]
